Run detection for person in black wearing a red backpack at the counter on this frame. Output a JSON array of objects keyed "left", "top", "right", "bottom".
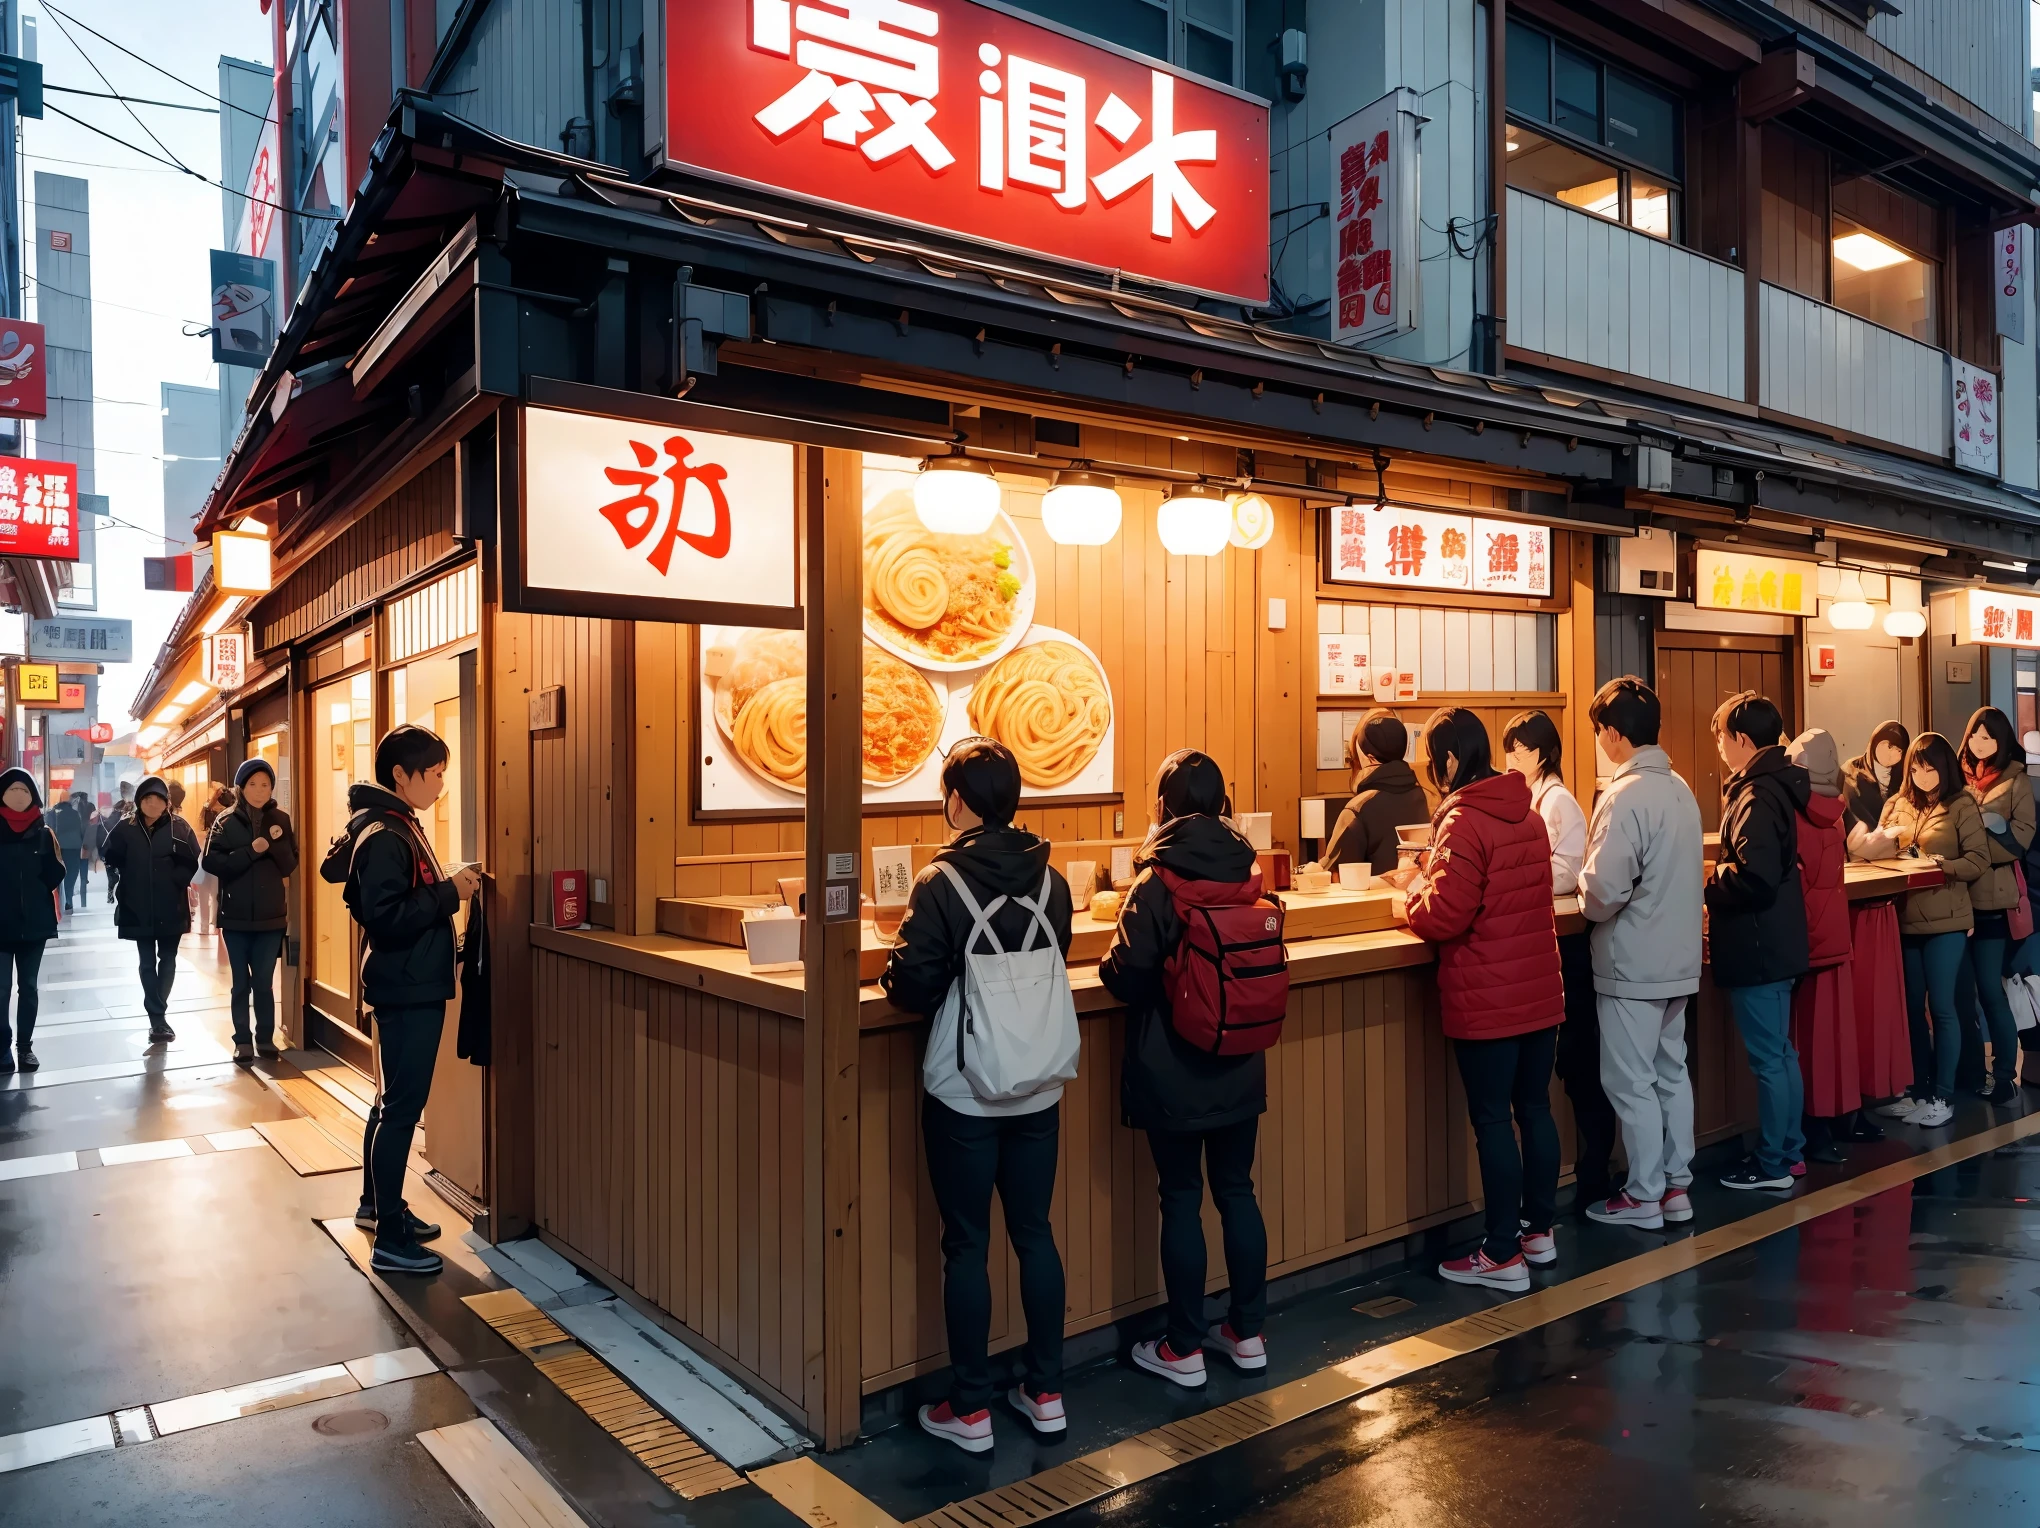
[{"left": 1098, "top": 749, "right": 1289, "bottom": 1389}]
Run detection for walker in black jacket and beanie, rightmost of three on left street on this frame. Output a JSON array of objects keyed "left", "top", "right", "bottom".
[{"left": 202, "top": 759, "right": 298, "bottom": 1067}]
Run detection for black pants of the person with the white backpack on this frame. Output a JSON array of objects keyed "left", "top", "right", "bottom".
[{"left": 920, "top": 1098, "right": 1063, "bottom": 1416}]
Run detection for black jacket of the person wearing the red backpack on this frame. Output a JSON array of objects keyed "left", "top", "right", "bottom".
[{"left": 1098, "top": 814, "right": 1269, "bottom": 1130}]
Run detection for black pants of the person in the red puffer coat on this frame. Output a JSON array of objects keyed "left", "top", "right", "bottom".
[{"left": 1452, "top": 1028, "right": 1559, "bottom": 1263}]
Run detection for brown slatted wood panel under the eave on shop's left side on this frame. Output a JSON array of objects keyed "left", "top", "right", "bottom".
[{"left": 255, "top": 455, "right": 453, "bottom": 651}]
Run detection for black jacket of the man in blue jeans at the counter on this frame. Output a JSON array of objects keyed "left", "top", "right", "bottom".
[{"left": 1707, "top": 747, "right": 1814, "bottom": 987}]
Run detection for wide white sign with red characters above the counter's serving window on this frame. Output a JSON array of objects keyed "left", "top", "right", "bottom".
[{"left": 1324, "top": 504, "right": 1552, "bottom": 596}]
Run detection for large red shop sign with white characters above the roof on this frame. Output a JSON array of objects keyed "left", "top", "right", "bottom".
[{"left": 665, "top": 0, "right": 1269, "bottom": 302}]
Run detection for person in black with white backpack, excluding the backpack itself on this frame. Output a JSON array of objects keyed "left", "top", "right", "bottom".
[{"left": 879, "top": 738, "right": 1071, "bottom": 1453}]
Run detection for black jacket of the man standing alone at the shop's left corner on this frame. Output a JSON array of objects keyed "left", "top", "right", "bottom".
[{"left": 318, "top": 785, "right": 461, "bottom": 1008}]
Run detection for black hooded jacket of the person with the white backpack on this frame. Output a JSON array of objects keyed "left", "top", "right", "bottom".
[{"left": 879, "top": 826, "right": 1069, "bottom": 1018}]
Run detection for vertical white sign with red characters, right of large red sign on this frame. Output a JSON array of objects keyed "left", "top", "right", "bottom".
[{"left": 1330, "top": 90, "right": 1418, "bottom": 345}]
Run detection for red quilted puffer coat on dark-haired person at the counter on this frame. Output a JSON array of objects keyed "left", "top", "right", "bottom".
[{"left": 1410, "top": 771, "right": 1565, "bottom": 1040}]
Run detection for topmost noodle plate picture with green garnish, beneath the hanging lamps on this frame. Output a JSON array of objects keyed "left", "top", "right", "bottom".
[{"left": 865, "top": 490, "right": 1032, "bottom": 667}]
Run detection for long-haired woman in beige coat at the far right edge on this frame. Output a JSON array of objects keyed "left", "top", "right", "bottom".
[{"left": 1954, "top": 706, "right": 2034, "bottom": 1104}]
